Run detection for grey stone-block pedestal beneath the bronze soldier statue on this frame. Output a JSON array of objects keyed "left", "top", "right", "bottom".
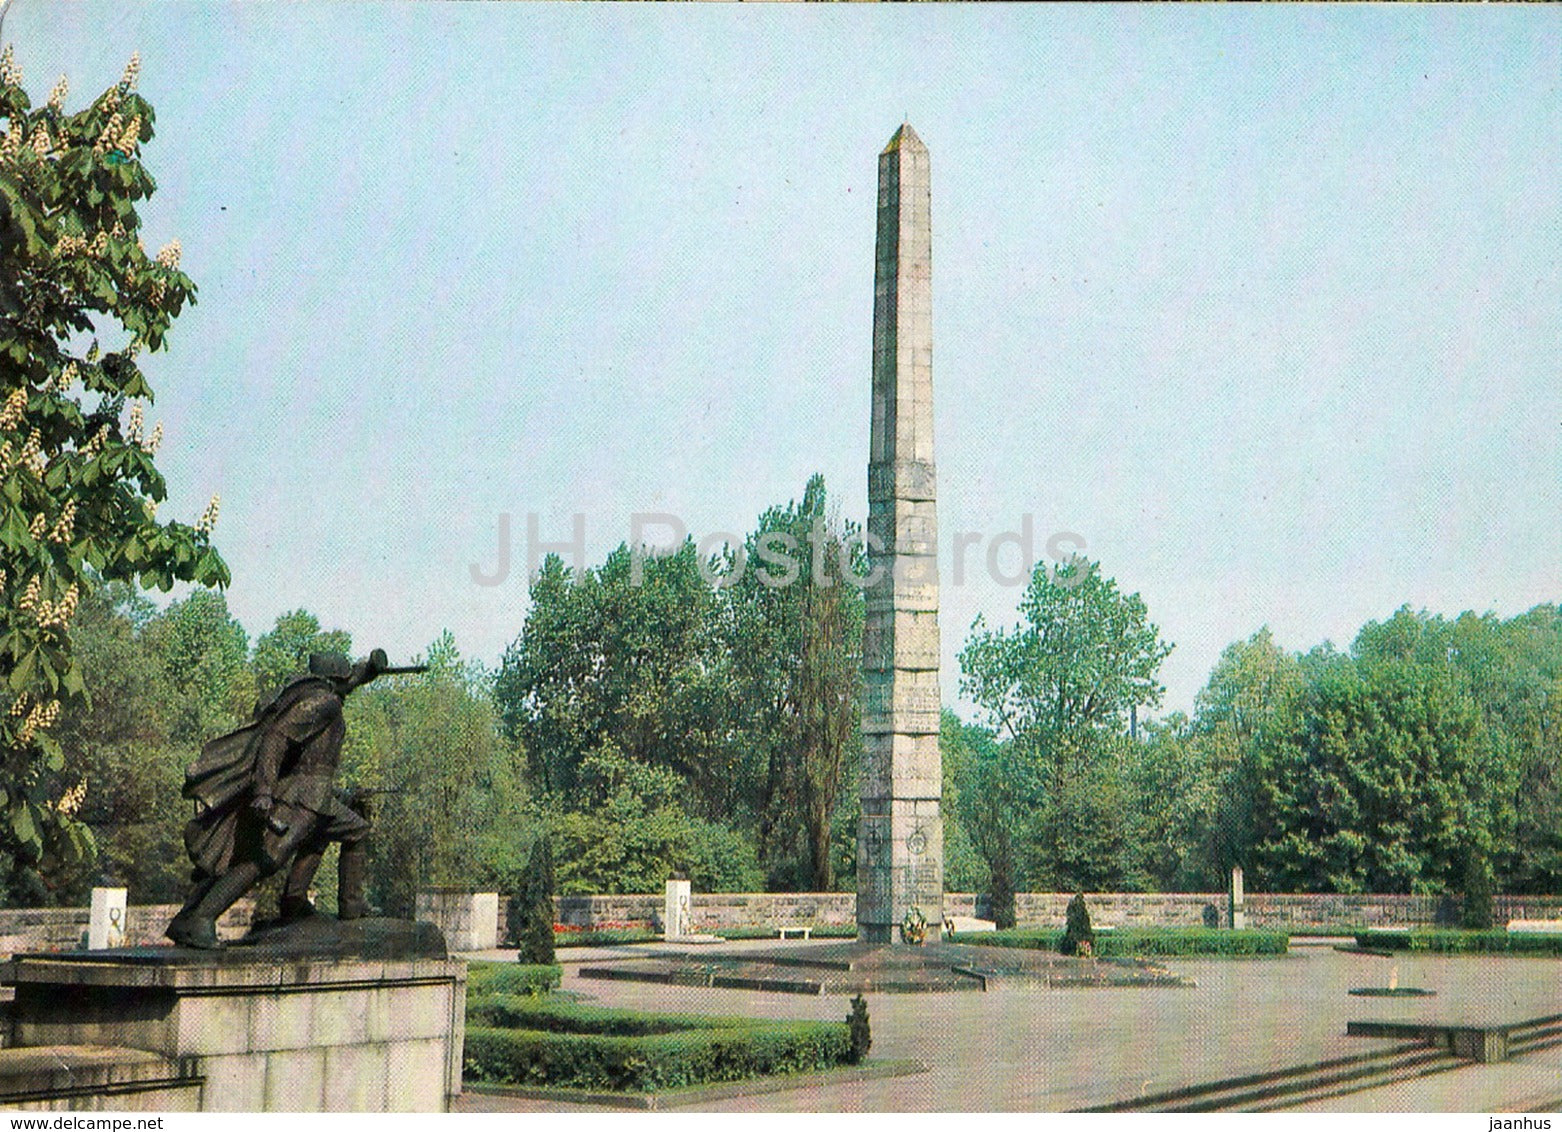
[{"left": 0, "top": 948, "right": 465, "bottom": 1112}]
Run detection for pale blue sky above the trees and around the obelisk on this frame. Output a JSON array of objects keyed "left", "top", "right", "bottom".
[{"left": 12, "top": 0, "right": 1562, "bottom": 710}]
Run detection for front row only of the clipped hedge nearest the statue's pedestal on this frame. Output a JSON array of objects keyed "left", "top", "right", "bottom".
[{"left": 465, "top": 1023, "right": 851, "bottom": 1091}]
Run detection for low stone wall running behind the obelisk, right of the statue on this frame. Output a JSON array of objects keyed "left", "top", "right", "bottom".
[{"left": 534, "top": 892, "right": 1562, "bottom": 938}]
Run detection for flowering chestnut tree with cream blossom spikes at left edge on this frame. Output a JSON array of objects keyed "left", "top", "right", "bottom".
[{"left": 0, "top": 48, "right": 228, "bottom": 874}]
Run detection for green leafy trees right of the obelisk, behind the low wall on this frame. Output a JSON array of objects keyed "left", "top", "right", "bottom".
[{"left": 943, "top": 568, "right": 1562, "bottom": 918}]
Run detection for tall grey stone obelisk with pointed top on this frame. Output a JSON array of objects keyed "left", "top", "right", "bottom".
[{"left": 858, "top": 123, "right": 943, "bottom": 943}]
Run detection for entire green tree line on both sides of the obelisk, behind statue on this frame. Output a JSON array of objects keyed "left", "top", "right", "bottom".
[{"left": 9, "top": 476, "right": 1562, "bottom": 920}]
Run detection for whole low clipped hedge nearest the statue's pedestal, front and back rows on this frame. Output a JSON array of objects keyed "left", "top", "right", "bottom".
[{"left": 464, "top": 995, "right": 853, "bottom": 1093}]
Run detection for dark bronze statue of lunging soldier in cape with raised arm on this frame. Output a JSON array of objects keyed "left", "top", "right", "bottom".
[{"left": 167, "top": 648, "right": 426, "bottom": 948}]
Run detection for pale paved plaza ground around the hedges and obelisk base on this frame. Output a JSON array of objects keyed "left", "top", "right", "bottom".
[{"left": 459, "top": 943, "right": 1562, "bottom": 1112}]
